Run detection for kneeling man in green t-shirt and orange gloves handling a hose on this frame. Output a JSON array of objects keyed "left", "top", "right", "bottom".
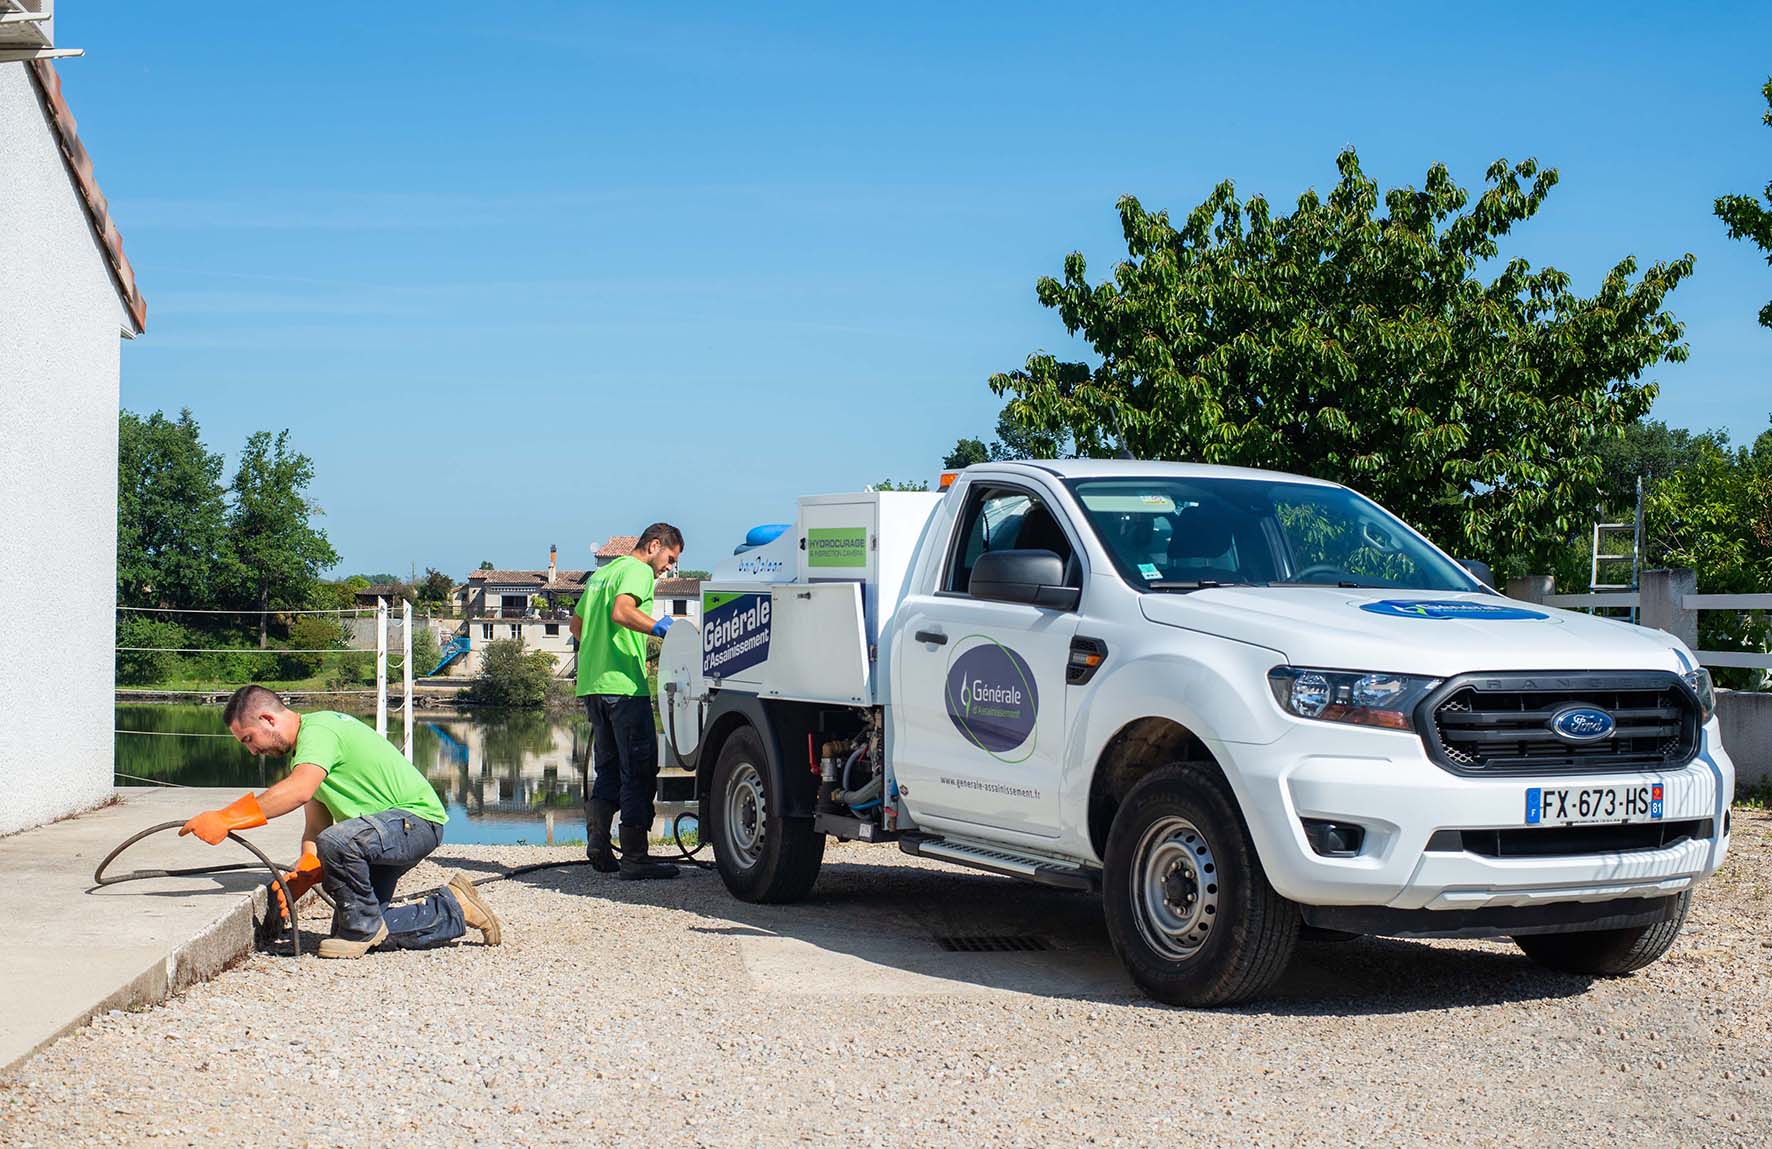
[{"left": 179, "top": 686, "right": 500, "bottom": 958}]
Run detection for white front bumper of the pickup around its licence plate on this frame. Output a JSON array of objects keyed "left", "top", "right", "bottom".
[{"left": 1210, "top": 720, "right": 1735, "bottom": 914}]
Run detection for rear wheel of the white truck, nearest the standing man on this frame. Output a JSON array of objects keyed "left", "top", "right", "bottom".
[{"left": 709, "top": 727, "right": 824, "bottom": 903}]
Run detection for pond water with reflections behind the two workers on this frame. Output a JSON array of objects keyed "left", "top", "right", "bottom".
[{"left": 117, "top": 702, "right": 691, "bottom": 846}]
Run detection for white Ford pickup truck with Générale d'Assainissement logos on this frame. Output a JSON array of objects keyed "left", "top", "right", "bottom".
[{"left": 659, "top": 459, "right": 1735, "bottom": 1005}]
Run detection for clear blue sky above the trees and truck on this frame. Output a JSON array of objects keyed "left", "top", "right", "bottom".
[{"left": 57, "top": 0, "right": 1772, "bottom": 576}]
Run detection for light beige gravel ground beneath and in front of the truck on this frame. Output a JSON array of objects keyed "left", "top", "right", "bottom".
[{"left": 0, "top": 810, "right": 1772, "bottom": 1149}]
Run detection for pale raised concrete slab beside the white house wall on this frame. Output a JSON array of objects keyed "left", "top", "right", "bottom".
[{"left": 0, "top": 787, "right": 301, "bottom": 1073}]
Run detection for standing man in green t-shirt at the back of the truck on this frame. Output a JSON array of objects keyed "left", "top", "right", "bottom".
[{"left": 571, "top": 523, "right": 682, "bottom": 878}]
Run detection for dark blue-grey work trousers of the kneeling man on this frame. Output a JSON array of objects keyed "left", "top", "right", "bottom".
[{"left": 314, "top": 810, "right": 468, "bottom": 949}]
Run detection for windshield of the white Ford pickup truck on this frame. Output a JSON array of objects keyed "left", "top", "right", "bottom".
[{"left": 1070, "top": 477, "right": 1483, "bottom": 590}]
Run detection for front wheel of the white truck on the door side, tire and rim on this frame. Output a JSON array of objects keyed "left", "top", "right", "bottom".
[{"left": 1102, "top": 762, "right": 1301, "bottom": 1007}]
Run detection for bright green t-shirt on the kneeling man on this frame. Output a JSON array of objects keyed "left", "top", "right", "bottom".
[{"left": 289, "top": 711, "right": 448, "bottom": 826}]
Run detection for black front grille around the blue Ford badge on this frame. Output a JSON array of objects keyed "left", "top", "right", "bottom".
[{"left": 1416, "top": 670, "right": 1698, "bottom": 777}]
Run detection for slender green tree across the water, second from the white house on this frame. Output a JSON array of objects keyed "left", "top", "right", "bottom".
[{"left": 227, "top": 431, "right": 338, "bottom": 649}]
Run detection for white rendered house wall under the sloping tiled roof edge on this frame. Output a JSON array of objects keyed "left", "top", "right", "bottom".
[{"left": 0, "top": 64, "right": 129, "bottom": 833}]
